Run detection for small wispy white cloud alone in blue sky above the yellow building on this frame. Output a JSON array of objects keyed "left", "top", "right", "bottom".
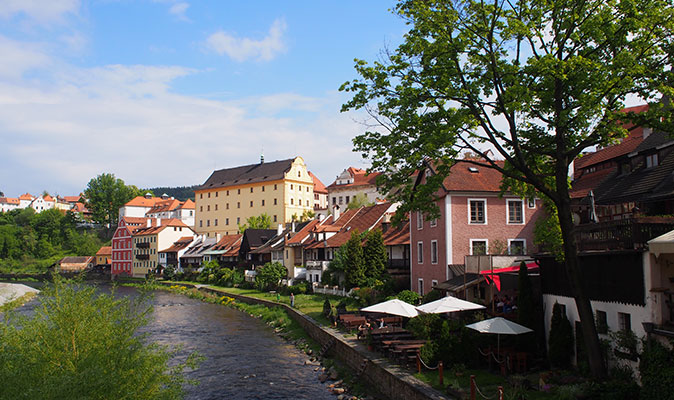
[{"left": 205, "top": 19, "right": 286, "bottom": 62}]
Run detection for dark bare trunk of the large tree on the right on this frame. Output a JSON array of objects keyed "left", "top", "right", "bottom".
[{"left": 557, "top": 195, "right": 606, "bottom": 379}]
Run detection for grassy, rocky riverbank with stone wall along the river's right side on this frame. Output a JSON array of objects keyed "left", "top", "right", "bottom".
[{"left": 152, "top": 282, "right": 448, "bottom": 400}]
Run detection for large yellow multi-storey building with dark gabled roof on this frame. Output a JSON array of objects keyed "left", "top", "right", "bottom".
[{"left": 194, "top": 157, "right": 314, "bottom": 237}]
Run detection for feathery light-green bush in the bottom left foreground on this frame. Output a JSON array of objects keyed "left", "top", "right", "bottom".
[{"left": 0, "top": 279, "right": 196, "bottom": 399}]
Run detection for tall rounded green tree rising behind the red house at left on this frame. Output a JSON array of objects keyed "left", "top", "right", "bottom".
[{"left": 84, "top": 173, "right": 142, "bottom": 227}]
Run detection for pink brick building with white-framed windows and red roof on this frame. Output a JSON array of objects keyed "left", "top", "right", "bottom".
[{"left": 410, "top": 161, "right": 543, "bottom": 294}]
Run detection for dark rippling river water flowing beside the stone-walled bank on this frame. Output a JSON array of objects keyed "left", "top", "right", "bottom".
[{"left": 13, "top": 287, "right": 335, "bottom": 400}]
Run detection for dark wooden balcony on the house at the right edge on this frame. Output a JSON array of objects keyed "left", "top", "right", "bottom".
[{"left": 575, "top": 217, "right": 674, "bottom": 251}]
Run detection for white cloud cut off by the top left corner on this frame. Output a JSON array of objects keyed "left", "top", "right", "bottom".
[{"left": 0, "top": 0, "right": 80, "bottom": 24}]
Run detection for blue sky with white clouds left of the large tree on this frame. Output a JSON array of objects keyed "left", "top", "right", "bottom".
[{"left": 0, "top": 0, "right": 407, "bottom": 197}]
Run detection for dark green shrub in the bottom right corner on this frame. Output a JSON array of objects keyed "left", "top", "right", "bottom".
[{"left": 639, "top": 339, "right": 674, "bottom": 400}]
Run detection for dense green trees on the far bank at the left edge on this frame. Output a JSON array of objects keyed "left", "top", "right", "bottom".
[{"left": 0, "top": 208, "right": 103, "bottom": 272}]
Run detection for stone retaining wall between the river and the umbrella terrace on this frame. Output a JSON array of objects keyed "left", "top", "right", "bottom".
[{"left": 192, "top": 285, "right": 448, "bottom": 400}]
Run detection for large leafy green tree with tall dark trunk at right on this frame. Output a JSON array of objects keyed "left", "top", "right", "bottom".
[{"left": 342, "top": 0, "right": 674, "bottom": 377}]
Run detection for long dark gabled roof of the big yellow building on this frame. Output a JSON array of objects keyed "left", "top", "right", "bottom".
[{"left": 195, "top": 158, "right": 295, "bottom": 190}]
